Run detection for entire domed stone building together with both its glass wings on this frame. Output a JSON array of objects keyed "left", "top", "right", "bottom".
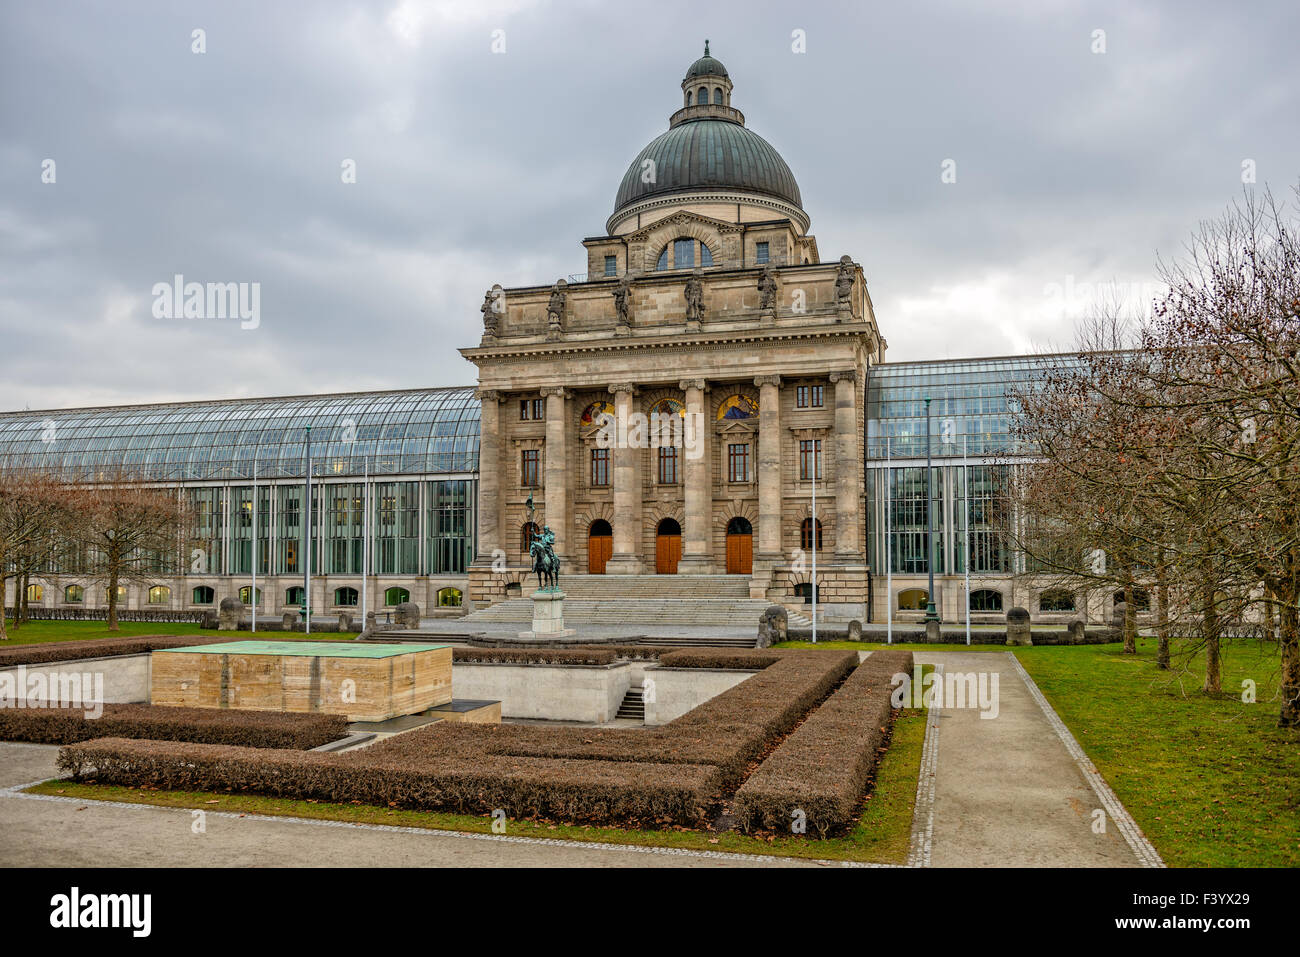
[{"left": 0, "top": 46, "right": 1106, "bottom": 629}]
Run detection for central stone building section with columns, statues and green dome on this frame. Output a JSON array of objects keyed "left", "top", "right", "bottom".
[{"left": 460, "top": 48, "right": 885, "bottom": 616}]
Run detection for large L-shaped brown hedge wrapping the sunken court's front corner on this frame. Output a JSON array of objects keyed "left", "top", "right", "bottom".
[{"left": 60, "top": 650, "right": 857, "bottom": 826}]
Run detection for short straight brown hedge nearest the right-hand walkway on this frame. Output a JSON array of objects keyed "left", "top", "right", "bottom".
[{"left": 735, "top": 650, "right": 913, "bottom": 836}]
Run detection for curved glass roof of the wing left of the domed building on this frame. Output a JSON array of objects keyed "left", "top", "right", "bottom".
[{"left": 0, "top": 387, "right": 480, "bottom": 482}]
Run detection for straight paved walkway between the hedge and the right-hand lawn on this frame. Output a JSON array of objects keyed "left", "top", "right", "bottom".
[{"left": 910, "top": 650, "right": 1160, "bottom": 867}]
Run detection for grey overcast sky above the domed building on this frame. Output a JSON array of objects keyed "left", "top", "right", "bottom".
[{"left": 0, "top": 0, "right": 1300, "bottom": 410}]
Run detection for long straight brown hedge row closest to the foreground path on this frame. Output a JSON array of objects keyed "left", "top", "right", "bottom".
[{"left": 59, "top": 726, "right": 718, "bottom": 826}]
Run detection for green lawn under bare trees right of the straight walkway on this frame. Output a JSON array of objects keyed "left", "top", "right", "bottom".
[{"left": 780, "top": 637, "right": 1300, "bottom": 867}]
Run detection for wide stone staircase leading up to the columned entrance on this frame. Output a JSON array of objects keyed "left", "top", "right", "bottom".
[{"left": 463, "top": 575, "right": 811, "bottom": 633}]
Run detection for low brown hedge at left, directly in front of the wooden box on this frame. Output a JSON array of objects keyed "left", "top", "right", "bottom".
[{"left": 0, "top": 705, "right": 347, "bottom": 750}]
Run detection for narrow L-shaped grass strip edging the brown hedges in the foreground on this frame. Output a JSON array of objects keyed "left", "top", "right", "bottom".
[{"left": 29, "top": 670, "right": 926, "bottom": 863}]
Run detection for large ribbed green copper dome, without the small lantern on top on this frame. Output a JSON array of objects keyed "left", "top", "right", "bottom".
[{"left": 614, "top": 118, "right": 803, "bottom": 213}]
